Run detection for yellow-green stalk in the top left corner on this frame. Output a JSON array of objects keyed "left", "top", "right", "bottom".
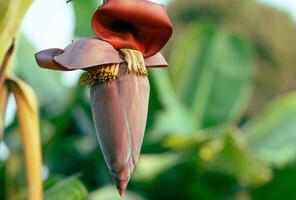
[{"left": 0, "top": 0, "right": 31, "bottom": 74}]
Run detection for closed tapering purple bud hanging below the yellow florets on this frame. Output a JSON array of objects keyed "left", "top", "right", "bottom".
[{"left": 90, "top": 64, "right": 150, "bottom": 194}]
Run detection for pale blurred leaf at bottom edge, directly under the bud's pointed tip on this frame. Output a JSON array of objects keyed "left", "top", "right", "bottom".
[{"left": 89, "top": 186, "right": 144, "bottom": 200}]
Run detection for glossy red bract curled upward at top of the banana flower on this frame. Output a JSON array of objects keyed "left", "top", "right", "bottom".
[{"left": 92, "top": 0, "right": 172, "bottom": 57}]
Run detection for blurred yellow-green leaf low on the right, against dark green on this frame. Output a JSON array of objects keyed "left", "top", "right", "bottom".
[{"left": 199, "top": 133, "right": 272, "bottom": 185}]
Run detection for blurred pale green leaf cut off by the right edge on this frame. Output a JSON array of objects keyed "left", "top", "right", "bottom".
[{"left": 243, "top": 93, "right": 296, "bottom": 166}]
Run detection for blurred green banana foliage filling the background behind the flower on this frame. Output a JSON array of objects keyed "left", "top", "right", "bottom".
[{"left": 0, "top": 0, "right": 296, "bottom": 200}]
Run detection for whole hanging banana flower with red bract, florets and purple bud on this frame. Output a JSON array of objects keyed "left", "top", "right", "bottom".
[{"left": 35, "top": 0, "right": 172, "bottom": 195}]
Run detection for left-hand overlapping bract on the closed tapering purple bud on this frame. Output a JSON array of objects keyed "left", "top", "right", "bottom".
[{"left": 91, "top": 77, "right": 132, "bottom": 174}]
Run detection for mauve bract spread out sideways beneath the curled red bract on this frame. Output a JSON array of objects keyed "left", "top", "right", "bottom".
[{"left": 35, "top": 38, "right": 168, "bottom": 71}]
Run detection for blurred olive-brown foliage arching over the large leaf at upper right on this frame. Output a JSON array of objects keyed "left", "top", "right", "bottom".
[{"left": 167, "top": 0, "right": 296, "bottom": 115}]
